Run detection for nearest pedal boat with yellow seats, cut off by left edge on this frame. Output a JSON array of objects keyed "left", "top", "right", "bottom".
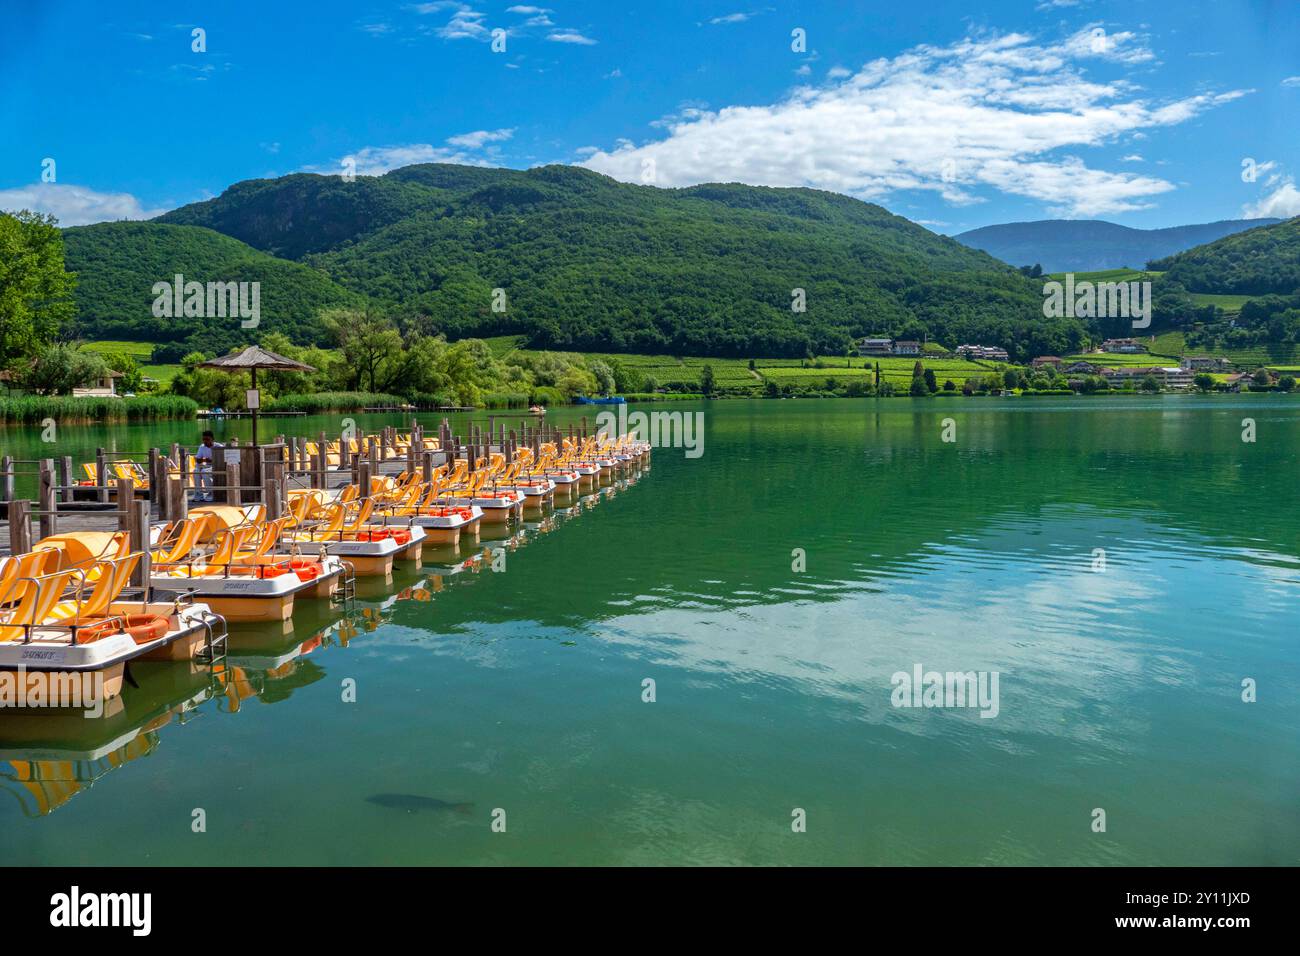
[{"left": 0, "top": 549, "right": 225, "bottom": 708}]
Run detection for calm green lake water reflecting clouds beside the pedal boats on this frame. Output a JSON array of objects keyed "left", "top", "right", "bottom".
[{"left": 0, "top": 395, "right": 1300, "bottom": 865}]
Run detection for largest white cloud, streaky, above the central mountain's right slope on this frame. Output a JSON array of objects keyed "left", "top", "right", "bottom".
[{"left": 582, "top": 26, "right": 1245, "bottom": 216}]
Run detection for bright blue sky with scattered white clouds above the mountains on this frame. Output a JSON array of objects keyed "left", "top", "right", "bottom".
[{"left": 0, "top": 0, "right": 1300, "bottom": 233}]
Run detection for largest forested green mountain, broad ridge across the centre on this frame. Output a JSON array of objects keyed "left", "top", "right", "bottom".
[{"left": 148, "top": 164, "right": 1086, "bottom": 358}]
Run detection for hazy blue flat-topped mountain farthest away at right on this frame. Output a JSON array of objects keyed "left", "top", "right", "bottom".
[{"left": 954, "top": 219, "right": 1282, "bottom": 272}]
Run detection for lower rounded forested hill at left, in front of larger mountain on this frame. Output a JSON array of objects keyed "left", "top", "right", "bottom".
[{"left": 64, "top": 222, "right": 361, "bottom": 342}]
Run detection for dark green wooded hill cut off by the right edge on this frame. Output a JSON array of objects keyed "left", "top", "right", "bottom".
[{"left": 1152, "top": 216, "right": 1300, "bottom": 295}]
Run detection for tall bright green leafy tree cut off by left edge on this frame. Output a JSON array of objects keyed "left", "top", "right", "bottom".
[{"left": 0, "top": 209, "right": 77, "bottom": 369}]
